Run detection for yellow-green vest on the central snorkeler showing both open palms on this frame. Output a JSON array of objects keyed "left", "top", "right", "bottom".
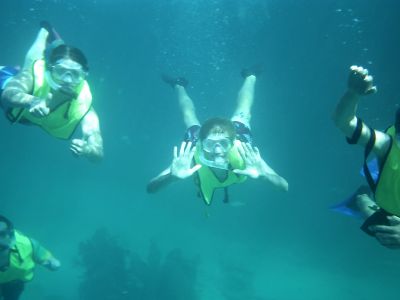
[{"left": 194, "top": 140, "right": 247, "bottom": 205}]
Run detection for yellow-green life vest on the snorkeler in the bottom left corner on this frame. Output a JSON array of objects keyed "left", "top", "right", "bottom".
[{"left": 0, "top": 231, "right": 35, "bottom": 284}]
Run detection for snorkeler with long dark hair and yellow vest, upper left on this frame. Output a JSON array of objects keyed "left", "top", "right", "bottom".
[{"left": 0, "top": 22, "right": 103, "bottom": 161}]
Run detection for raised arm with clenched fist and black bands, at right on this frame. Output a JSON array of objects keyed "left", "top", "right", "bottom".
[{"left": 333, "top": 66, "right": 390, "bottom": 157}]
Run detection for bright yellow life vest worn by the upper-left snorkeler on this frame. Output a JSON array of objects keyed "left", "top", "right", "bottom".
[{"left": 7, "top": 60, "right": 92, "bottom": 140}]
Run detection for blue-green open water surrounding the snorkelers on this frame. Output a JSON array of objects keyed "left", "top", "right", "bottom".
[{"left": 0, "top": 0, "right": 400, "bottom": 300}]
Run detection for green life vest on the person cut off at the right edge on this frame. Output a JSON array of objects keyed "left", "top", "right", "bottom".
[{"left": 375, "top": 126, "right": 400, "bottom": 217}]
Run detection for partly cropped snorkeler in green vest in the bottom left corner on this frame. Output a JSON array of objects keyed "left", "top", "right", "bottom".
[{"left": 0, "top": 215, "right": 61, "bottom": 300}]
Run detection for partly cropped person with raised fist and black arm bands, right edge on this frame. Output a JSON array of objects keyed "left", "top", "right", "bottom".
[{"left": 333, "top": 66, "right": 400, "bottom": 248}]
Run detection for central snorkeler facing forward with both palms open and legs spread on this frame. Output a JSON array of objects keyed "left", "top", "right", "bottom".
[{"left": 147, "top": 66, "right": 288, "bottom": 205}]
